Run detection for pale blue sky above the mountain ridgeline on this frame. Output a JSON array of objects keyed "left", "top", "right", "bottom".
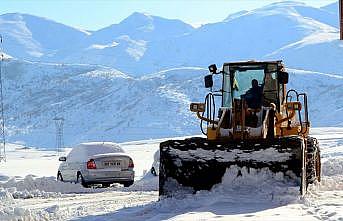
[{"left": 0, "top": 0, "right": 337, "bottom": 30}]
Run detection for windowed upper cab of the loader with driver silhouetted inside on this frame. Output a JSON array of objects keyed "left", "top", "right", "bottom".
[{"left": 222, "top": 61, "right": 288, "bottom": 110}]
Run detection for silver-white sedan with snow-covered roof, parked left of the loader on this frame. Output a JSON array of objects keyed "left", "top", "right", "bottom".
[{"left": 57, "top": 142, "right": 135, "bottom": 187}]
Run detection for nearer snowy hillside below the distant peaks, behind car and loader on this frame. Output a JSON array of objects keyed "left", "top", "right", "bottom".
[{"left": 3, "top": 60, "right": 343, "bottom": 147}]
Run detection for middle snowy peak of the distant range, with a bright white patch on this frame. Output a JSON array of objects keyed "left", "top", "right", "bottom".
[{"left": 55, "top": 12, "right": 193, "bottom": 73}]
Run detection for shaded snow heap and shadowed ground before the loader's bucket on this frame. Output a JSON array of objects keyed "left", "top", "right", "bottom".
[{"left": 113, "top": 167, "right": 301, "bottom": 220}]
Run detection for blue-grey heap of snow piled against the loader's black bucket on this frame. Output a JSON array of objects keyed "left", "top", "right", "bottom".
[{"left": 211, "top": 166, "right": 300, "bottom": 203}]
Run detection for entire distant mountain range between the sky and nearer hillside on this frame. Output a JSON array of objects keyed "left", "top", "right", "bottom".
[{"left": 0, "top": 1, "right": 343, "bottom": 75}]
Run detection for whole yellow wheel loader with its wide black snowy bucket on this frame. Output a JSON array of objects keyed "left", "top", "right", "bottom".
[{"left": 159, "top": 61, "right": 321, "bottom": 196}]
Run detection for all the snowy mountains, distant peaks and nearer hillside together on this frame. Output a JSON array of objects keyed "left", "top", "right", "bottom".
[{"left": 0, "top": 2, "right": 343, "bottom": 147}]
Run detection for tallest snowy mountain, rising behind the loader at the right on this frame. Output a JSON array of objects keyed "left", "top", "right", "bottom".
[{"left": 123, "top": 2, "right": 342, "bottom": 73}]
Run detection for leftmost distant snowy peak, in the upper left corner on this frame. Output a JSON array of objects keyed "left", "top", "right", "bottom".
[{"left": 0, "top": 13, "right": 88, "bottom": 60}]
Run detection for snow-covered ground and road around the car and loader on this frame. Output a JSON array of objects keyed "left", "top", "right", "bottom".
[{"left": 0, "top": 128, "right": 343, "bottom": 221}]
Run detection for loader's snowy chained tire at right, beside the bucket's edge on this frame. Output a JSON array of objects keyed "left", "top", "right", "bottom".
[{"left": 306, "top": 137, "right": 321, "bottom": 184}]
